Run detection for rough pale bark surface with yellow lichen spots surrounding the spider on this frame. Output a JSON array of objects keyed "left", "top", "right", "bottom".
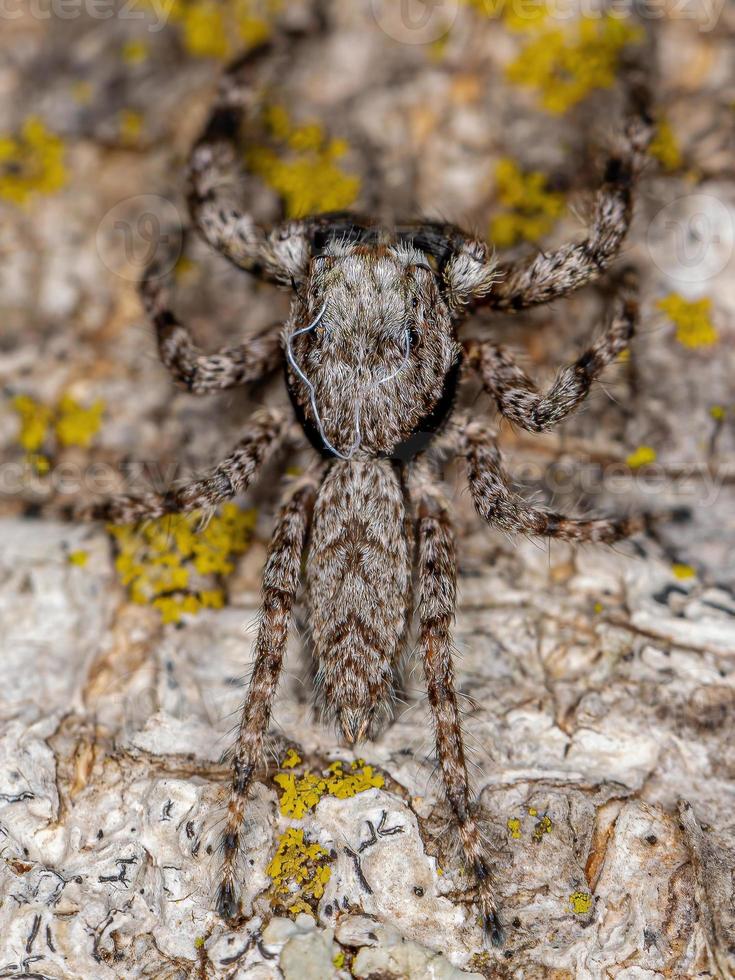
[{"left": 0, "top": 0, "right": 735, "bottom": 980}]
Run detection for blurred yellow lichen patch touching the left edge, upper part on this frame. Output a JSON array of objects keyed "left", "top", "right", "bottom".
[{"left": 0, "top": 116, "right": 67, "bottom": 204}]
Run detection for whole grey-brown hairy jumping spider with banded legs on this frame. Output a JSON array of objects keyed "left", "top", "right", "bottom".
[{"left": 89, "top": 40, "right": 651, "bottom": 942}]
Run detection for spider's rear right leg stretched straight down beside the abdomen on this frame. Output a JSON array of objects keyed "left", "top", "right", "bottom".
[{"left": 410, "top": 462, "right": 502, "bottom": 945}]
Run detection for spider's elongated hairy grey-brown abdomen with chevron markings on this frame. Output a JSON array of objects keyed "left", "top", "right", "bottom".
[{"left": 307, "top": 460, "right": 410, "bottom": 742}]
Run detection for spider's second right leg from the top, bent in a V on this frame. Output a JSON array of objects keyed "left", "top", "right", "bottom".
[{"left": 465, "top": 274, "right": 638, "bottom": 432}]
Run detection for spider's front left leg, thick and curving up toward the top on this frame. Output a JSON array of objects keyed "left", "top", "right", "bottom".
[{"left": 188, "top": 42, "right": 309, "bottom": 284}]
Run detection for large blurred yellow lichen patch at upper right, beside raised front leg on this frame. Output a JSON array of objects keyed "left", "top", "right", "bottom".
[{"left": 506, "top": 14, "right": 642, "bottom": 114}]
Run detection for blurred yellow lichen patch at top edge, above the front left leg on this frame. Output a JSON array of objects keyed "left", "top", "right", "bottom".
[{"left": 160, "top": 0, "right": 283, "bottom": 60}]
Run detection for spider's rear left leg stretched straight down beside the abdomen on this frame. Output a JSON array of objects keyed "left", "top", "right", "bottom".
[{"left": 217, "top": 477, "right": 318, "bottom": 919}]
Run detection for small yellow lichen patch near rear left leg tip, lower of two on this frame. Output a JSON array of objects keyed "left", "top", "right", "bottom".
[{"left": 266, "top": 827, "right": 332, "bottom": 915}]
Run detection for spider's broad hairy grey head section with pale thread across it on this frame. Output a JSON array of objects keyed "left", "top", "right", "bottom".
[{"left": 284, "top": 242, "right": 459, "bottom": 459}]
